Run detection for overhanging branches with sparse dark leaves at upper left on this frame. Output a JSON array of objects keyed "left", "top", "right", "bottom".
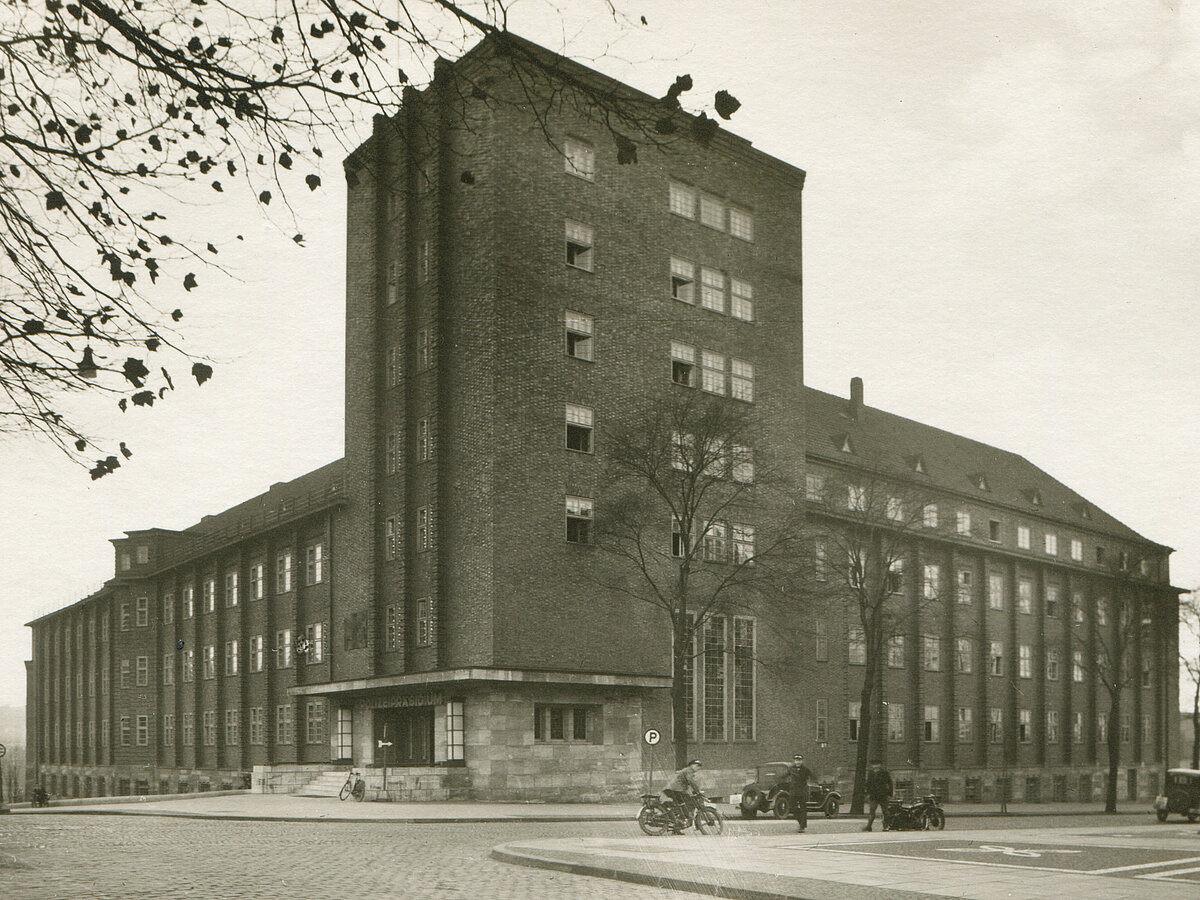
[{"left": 0, "top": 0, "right": 738, "bottom": 478}]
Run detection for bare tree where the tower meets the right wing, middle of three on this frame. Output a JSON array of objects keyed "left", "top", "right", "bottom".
[{"left": 806, "top": 464, "right": 940, "bottom": 815}]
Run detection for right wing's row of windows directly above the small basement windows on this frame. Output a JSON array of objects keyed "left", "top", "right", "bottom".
[{"left": 840, "top": 700, "right": 1153, "bottom": 744}]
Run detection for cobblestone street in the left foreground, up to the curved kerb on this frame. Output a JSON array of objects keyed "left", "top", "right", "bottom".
[{"left": 0, "top": 815, "right": 696, "bottom": 900}]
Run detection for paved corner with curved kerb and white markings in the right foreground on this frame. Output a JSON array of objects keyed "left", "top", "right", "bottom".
[{"left": 492, "top": 820, "right": 1200, "bottom": 900}]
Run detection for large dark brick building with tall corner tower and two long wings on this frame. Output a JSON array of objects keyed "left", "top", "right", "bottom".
[{"left": 29, "top": 37, "right": 1177, "bottom": 798}]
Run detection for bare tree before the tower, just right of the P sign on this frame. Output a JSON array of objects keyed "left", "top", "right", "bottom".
[{"left": 594, "top": 392, "right": 803, "bottom": 768}]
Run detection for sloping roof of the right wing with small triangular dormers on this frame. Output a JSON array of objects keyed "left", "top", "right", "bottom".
[{"left": 804, "top": 388, "right": 1163, "bottom": 546}]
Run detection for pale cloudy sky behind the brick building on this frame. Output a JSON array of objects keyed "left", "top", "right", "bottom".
[{"left": 0, "top": 0, "right": 1200, "bottom": 720}]
